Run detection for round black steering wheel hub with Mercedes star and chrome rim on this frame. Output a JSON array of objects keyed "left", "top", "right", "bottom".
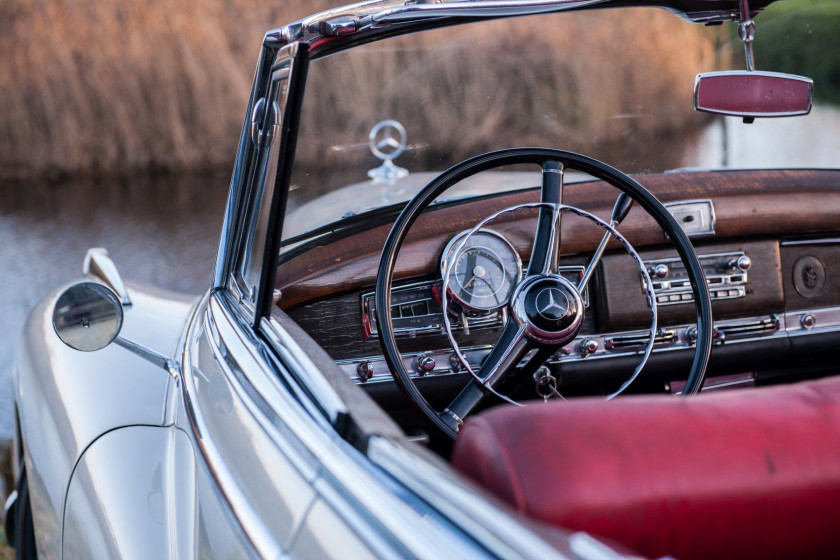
[{"left": 511, "top": 274, "right": 584, "bottom": 345}]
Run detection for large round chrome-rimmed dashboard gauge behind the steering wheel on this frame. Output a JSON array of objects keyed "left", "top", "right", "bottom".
[{"left": 440, "top": 229, "right": 522, "bottom": 311}]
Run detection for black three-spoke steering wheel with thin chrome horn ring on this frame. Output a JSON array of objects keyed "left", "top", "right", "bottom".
[{"left": 375, "top": 148, "right": 713, "bottom": 439}]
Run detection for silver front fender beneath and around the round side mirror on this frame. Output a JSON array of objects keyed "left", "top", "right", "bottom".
[{"left": 12, "top": 285, "right": 197, "bottom": 557}]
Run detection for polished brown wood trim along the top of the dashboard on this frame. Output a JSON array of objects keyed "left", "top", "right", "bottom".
[{"left": 276, "top": 170, "right": 840, "bottom": 309}]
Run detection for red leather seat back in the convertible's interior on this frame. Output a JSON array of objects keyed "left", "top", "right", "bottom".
[{"left": 453, "top": 378, "right": 840, "bottom": 559}]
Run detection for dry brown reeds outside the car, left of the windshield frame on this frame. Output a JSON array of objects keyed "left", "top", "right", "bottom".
[{"left": 0, "top": 0, "right": 328, "bottom": 177}]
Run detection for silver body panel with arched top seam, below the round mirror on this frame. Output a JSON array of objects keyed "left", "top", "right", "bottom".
[{"left": 62, "top": 426, "right": 196, "bottom": 560}]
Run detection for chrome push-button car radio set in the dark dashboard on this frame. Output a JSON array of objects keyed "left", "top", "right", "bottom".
[{"left": 645, "top": 251, "right": 752, "bottom": 305}]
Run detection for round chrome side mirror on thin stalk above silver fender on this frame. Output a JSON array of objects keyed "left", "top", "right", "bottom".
[{"left": 53, "top": 282, "right": 123, "bottom": 352}]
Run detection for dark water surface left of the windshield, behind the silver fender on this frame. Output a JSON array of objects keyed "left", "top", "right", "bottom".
[{"left": 0, "top": 175, "right": 229, "bottom": 438}]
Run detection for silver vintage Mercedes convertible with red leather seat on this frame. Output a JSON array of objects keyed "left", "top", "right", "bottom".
[{"left": 5, "top": 0, "right": 840, "bottom": 559}]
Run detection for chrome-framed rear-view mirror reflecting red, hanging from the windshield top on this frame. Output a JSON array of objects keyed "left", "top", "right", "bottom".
[{"left": 694, "top": 70, "right": 814, "bottom": 119}]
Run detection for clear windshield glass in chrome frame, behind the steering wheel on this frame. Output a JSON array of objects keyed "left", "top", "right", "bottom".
[{"left": 283, "top": 1, "right": 840, "bottom": 240}]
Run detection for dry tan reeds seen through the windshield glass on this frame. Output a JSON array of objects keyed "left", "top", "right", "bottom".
[{"left": 298, "top": 9, "right": 716, "bottom": 169}]
